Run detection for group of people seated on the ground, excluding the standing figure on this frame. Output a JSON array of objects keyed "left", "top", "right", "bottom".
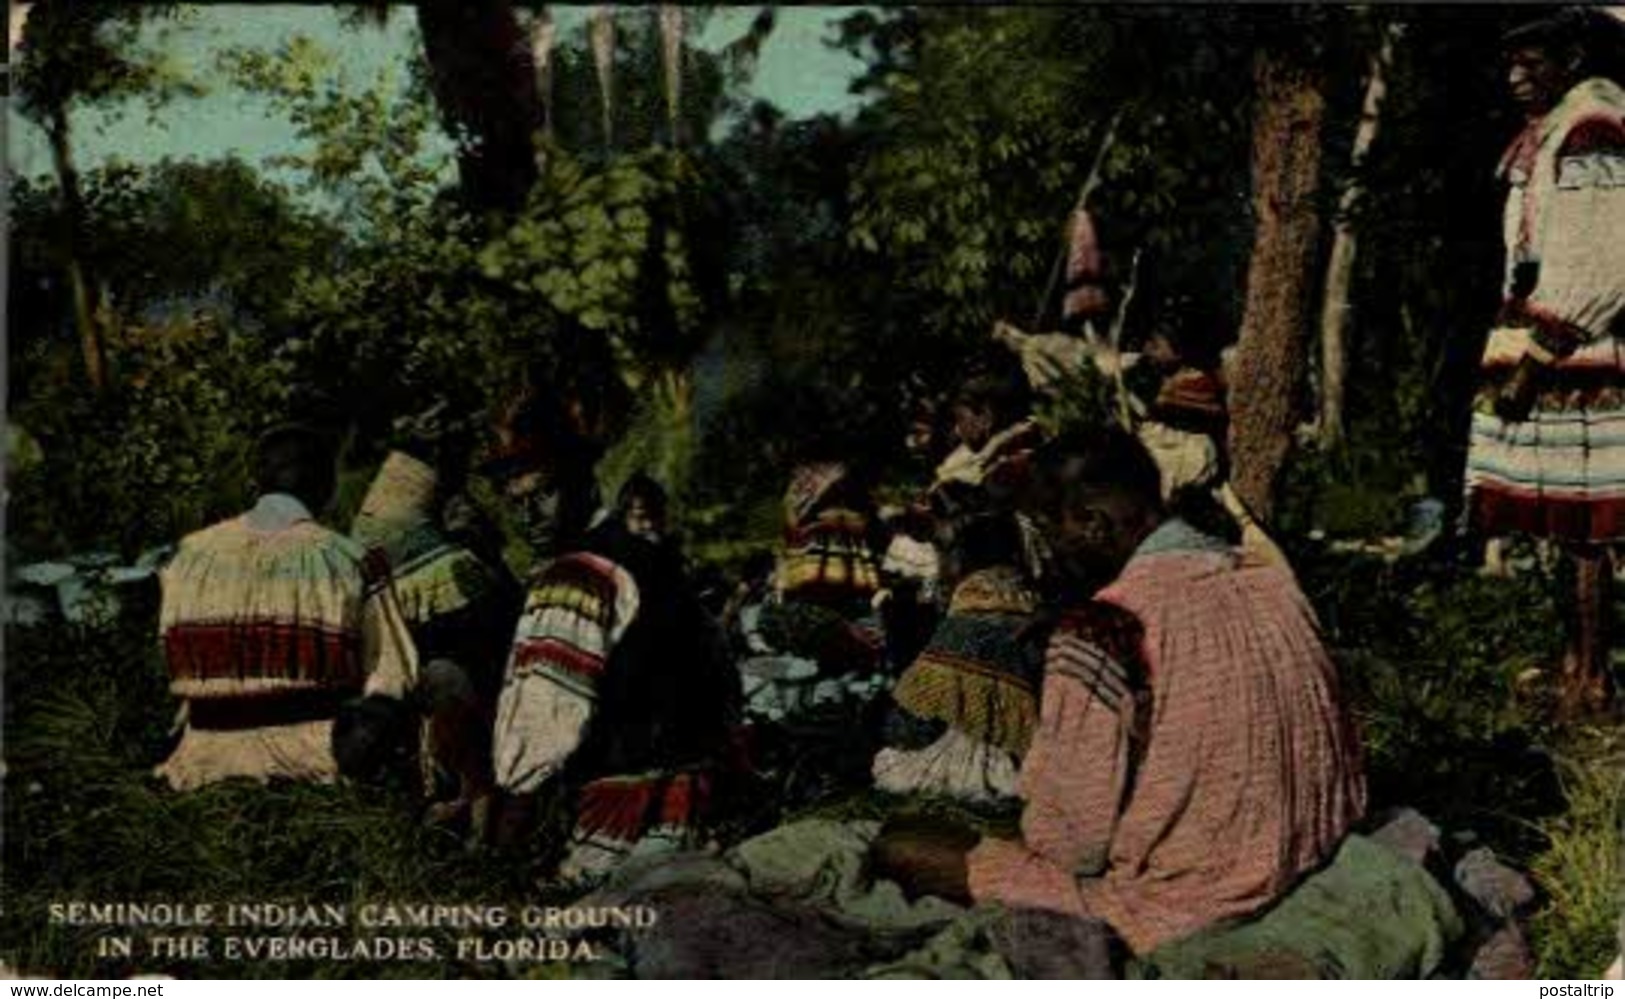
[{"left": 149, "top": 324, "right": 1365, "bottom": 968}]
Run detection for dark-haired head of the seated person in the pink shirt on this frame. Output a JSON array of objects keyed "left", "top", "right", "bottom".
[{"left": 1025, "top": 427, "right": 1165, "bottom": 596}]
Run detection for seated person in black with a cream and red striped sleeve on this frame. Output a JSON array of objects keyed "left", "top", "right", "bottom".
[{"left": 481, "top": 493, "right": 739, "bottom": 879}]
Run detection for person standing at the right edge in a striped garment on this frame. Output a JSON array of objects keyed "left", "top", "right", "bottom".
[{"left": 1466, "top": 10, "right": 1625, "bottom": 715}]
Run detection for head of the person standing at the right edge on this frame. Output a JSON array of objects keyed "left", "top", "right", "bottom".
[{"left": 1502, "top": 8, "right": 1620, "bottom": 117}]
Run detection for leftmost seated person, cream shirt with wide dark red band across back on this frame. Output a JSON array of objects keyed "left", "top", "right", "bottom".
[{"left": 158, "top": 426, "right": 418, "bottom": 789}]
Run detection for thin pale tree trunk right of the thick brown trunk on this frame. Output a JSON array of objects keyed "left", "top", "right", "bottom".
[{"left": 1318, "top": 24, "right": 1404, "bottom": 447}]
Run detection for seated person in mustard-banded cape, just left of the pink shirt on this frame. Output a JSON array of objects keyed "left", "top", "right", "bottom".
[{"left": 873, "top": 484, "right": 1042, "bottom": 804}]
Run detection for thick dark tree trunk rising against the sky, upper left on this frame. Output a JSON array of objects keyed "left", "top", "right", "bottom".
[{"left": 418, "top": 0, "right": 541, "bottom": 213}]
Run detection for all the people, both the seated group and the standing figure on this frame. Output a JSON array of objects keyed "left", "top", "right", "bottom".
[{"left": 143, "top": 7, "right": 1625, "bottom": 974}]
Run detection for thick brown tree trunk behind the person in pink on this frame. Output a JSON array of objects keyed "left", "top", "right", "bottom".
[{"left": 1230, "top": 50, "right": 1326, "bottom": 523}]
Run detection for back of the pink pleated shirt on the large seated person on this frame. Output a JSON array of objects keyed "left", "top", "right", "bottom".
[{"left": 1084, "top": 521, "right": 1365, "bottom": 950}]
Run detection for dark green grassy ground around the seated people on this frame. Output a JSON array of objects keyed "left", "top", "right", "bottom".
[{"left": 0, "top": 552, "right": 1625, "bottom": 978}]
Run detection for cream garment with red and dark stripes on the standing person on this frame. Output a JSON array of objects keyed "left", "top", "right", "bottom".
[{"left": 1466, "top": 80, "right": 1625, "bottom": 541}]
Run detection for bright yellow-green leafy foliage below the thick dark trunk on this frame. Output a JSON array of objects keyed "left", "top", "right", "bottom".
[{"left": 286, "top": 142, "right": 724, "bottom": 454}]
